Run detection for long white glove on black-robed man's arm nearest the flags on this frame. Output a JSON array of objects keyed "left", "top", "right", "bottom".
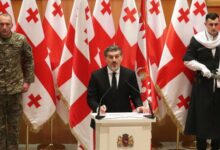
[{"left": 184, "top": 60, "right": 212, "bottom": 78}]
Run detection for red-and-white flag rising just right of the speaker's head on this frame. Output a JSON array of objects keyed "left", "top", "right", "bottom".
[{"left": 115, "top": 0, "right": 139, "bottom": 70}]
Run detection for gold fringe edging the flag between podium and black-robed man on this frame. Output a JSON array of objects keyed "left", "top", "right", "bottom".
[{"left": 155, "top": 85, "right": 183, "bottom": 133}]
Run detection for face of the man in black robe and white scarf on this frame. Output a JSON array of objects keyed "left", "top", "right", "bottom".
[{"left": 205, "top": 18, "right": 219, "bottom": 36}]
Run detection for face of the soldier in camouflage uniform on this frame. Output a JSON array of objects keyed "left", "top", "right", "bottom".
[{"left": 0, "top": 15, "right": 12, "bottom": 38}]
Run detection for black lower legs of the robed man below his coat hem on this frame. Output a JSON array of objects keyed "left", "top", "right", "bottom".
[{"left": 196, "top": 137, "right": 220, "bottom": 150}]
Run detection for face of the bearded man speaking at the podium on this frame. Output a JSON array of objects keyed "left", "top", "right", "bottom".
[{"left": 105, "top": 51, "right": 122, "bottom": 71}]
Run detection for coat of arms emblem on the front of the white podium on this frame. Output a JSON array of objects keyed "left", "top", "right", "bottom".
[{"left": 117, "top": 133, "right": 134, "bottom": 147}]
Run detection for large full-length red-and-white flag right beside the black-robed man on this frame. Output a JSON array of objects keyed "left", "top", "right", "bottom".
[{"left": 157, "top": 0, "right": 193, "bottom": 131}]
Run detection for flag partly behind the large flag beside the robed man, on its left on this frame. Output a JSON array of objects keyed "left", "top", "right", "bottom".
[{"left": 146, "top": 0, "right": 167, "bottom": 78}]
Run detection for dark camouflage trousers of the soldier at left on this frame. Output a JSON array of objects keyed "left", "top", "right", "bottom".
[{"left": 0, "top": 94, "right": 22, "bottom": 150}]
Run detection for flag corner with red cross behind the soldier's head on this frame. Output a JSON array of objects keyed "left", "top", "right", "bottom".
[{"left": 0, "top": 0, "right": 16, "bottom": 31}]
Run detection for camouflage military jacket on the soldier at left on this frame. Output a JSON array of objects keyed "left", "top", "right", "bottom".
[{"left": 0, "top": 32, "right": 34, "bottom": 95}]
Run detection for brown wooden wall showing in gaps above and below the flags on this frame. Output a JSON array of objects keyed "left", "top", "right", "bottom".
[{"left": 7, "top": 0, "right": 220, "bottom": 144}]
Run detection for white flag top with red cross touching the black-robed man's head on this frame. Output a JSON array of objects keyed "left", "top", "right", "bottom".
[{"left": 190, "top": 0, "right": 208, "bottom": 33}]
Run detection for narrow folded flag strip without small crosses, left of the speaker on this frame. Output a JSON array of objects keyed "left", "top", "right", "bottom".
[{"left": 57, "top": 0, "right": 81, "bottom": 124}]
